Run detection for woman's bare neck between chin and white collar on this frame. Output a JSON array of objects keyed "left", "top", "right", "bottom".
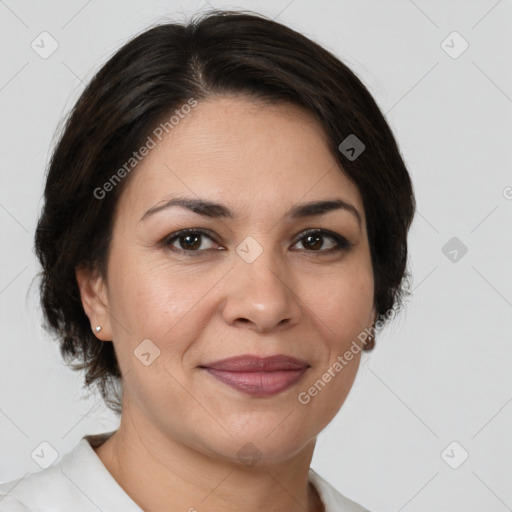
[{"left": 95, "top": 411, "right": 324, "bottom": 512}]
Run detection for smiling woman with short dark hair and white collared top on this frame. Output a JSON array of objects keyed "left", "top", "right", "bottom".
[{"left": 0, "top": 11, "right": 414, "bottom": 512}]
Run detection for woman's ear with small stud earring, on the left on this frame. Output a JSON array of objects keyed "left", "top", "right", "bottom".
[{"left": 75, "top": 267, "right": 112, "bottom": 341}]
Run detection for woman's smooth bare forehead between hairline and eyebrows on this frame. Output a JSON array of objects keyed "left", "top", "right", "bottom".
[{"left": 119, "top": 97, "right": 364, "bottom": 222}]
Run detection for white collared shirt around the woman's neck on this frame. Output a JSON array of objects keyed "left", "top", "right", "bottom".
[{"left": 0, "top": 431, "right": 369, "bottom": 512}]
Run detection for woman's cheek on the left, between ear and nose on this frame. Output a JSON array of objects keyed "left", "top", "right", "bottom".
[{"left": 109, "top": 254, "right": 219, "bottom": 369}]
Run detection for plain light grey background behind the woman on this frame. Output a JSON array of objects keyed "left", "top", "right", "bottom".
[{"left": 0, "top": 0, "right": 512, "bottom": 512}]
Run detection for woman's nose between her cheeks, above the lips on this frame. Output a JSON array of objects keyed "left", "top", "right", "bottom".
[{"left": 222, "top": 249, "right": 300, "bottom": 333}]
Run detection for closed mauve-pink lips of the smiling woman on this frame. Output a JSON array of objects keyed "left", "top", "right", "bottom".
[{"left": 200, "top": 354, "right": 311, "bottom": 397}]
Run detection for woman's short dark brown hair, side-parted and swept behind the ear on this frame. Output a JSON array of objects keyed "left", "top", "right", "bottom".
[{"left": 35, "top": 10, "right": 415, "bottom": 413}]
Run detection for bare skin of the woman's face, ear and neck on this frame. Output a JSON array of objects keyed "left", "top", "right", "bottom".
[{"left": 77, "top": 96, "right": 376, "bottom": 512}]
